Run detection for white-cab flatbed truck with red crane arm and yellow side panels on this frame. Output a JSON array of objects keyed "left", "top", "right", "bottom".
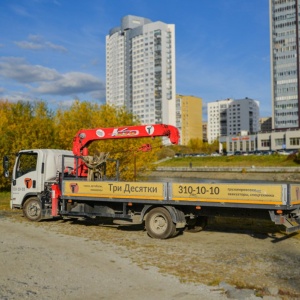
[{"left": 3, "top": 124, "right": 300, "bottom": 239}]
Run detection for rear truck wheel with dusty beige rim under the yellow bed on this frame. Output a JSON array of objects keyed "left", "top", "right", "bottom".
[{"left": 145, "top": 207, "right": 176, "bottom": 239}]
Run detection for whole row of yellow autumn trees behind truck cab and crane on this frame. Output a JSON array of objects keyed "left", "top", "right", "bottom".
[{"left": 0, "top": 100, "right": 162, "bottom": 190}]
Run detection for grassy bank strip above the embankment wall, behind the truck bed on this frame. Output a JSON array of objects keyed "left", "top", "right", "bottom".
[{"left": 158, "top": 155, "right": 300, "bottom": 167}]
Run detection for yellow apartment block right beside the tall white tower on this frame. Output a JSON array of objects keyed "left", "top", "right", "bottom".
[{"left": 176, "top": 95, "right": 202, "bottom": 145}]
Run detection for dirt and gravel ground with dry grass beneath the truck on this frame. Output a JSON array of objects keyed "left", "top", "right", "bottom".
[{"left": 0, "top": 172, "right": 300, "bottom": 300}]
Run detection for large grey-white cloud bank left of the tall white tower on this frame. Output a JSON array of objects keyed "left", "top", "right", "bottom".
[{"left": 0, "top": 57, "right": 105, "bottom": 101}]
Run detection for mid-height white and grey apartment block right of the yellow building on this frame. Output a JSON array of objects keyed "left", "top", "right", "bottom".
[{"left": 207, "top": 98, "right": 260, "bottom": 143}]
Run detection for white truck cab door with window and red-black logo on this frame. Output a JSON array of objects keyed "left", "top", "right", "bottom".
[{"left": 11, "top": 151, "right": 41, "bottom": 207}]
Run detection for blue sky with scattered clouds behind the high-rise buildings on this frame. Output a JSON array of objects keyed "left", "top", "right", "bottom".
[{"left": 0, "top": 0, "right": 271, "bottom": 116}]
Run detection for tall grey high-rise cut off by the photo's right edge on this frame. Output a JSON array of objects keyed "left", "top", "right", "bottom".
[{"left": 269, "top": 0, "right": 300, "bottom": 129}]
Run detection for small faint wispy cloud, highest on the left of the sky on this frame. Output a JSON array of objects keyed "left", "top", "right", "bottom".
[{"left": 14, "top": 35, "right": 68, "bottom": 52}]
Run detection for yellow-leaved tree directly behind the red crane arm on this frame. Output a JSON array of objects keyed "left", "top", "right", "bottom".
[{"left": 55, "top": 101, "right": 161, "bottom": 180}]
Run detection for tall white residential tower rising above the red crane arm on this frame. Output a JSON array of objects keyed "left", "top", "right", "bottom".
[{"left": 106, "top": 15, "right": 176, "bottom": 126}]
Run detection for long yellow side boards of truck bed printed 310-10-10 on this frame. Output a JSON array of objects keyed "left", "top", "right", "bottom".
[{"left": 62, "top": 179, "right": 300, "bottom": 208}]
